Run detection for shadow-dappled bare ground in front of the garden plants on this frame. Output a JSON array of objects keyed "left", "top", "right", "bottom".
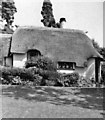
[{"left": 0, "top": 85, "right": 105, "bottom": 118}]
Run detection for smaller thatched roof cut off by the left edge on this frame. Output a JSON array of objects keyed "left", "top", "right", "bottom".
[{"left": 0, "top": 34, "right": 11, "bottom": 59}]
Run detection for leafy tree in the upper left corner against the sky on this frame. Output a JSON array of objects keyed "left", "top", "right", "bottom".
[{"left": 2, "top": 0, "right": 17, "bottom": 28}]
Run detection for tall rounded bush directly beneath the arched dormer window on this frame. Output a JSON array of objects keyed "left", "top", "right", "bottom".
[{"left": 25, "top": 57, "right": 57, "bottom": 71}]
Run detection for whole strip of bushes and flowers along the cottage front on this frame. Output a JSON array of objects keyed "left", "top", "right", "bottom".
[{"left": 0, "top": 57, "right": 105, "bottom": 87}]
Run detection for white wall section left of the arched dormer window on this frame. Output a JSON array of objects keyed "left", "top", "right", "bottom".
[{"left": 13, "top": 54, "right": 27, "bottom": 68}]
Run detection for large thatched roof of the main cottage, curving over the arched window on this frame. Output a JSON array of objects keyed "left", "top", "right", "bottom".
[{"left": 11, "top": 27, "right": 101, "bottom": 66}]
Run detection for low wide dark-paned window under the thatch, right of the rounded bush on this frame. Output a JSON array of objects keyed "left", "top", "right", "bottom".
[{"left": 58, "top": 62, "right": 76, "bottom": 70}]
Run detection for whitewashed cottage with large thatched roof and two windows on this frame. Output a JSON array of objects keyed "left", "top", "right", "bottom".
[{"left": 0, "top": 27, "right": 102, "bottom": 82}]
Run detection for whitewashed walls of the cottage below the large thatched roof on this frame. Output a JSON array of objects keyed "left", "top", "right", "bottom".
[{"left": 13, "top": 54, "right": 95, "bottom": 78}]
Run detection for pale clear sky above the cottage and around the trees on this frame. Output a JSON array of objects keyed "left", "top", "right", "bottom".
[{"left": 14, "top": 0, "right": 103, "bottom": 47}]
